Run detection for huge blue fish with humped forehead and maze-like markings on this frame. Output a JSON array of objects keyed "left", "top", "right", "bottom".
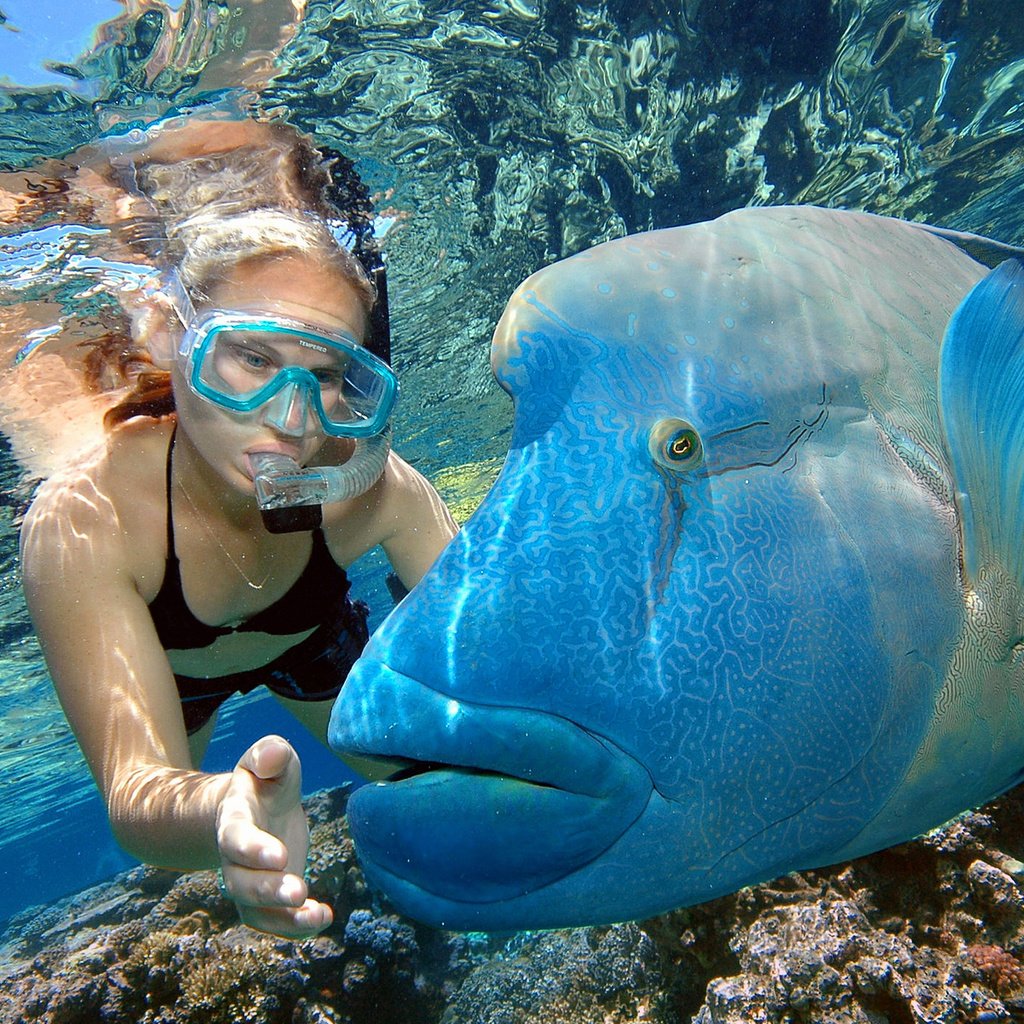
[{"left": 331, "top": 208, "right": 1024, "bottom": 930}]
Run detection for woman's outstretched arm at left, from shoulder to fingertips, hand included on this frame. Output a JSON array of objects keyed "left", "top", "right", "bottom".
[{"left": 22, "top": 473, "right": 331, "bottom": 936}]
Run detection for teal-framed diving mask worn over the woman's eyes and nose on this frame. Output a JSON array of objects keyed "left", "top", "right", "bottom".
[{"left": 178, "top": 309, "right": 398, "bottom": 437}]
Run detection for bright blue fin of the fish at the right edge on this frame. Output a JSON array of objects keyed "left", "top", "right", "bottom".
[{"left": 939, "top": 259, "right": 1024, "bottom": 584}]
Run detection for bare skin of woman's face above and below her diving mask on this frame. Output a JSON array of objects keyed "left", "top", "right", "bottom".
[{"left": 172, "top": 256, "right": 367, "bottom": 493}]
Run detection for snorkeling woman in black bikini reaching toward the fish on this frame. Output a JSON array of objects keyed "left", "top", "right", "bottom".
[{"left": 14, "top": 197, "right": 455, "bottom": 937}]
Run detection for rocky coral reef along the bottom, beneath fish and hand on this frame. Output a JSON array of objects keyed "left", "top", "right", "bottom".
[{"left": 6, "top": 788, "right": 1024, "bottom": 1024}]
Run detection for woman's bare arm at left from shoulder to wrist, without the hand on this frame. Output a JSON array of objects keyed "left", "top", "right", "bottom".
[{"left": 22, "top": 473, "right": 227, "bottom": 869}]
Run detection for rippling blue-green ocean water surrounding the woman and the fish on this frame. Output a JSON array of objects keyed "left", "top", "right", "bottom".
[{"left": 0, "top": 0, "right": 1024, "bottom": 933}]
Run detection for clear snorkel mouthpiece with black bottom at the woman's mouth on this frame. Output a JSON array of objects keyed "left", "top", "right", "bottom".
[{"left": 251, "top": 430, "right": 391, "bottom": 534}]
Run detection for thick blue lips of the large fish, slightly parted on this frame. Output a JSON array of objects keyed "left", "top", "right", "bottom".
[{"left": 329, "top": 659, "right": 652, "bottom": 928}]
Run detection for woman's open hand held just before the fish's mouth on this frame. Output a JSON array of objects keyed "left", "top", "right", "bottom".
[{"left": 217, "top": 736, "right": 334, "bottom": 939}]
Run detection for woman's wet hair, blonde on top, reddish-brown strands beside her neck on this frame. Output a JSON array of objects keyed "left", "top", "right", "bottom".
[{"left": 103, "top": 204, "right": 375, "bottom": 429}]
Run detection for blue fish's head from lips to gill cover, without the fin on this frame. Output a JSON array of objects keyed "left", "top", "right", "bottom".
[{"left": 331, "top": 214, "right": 966, "bottom": 931}]
